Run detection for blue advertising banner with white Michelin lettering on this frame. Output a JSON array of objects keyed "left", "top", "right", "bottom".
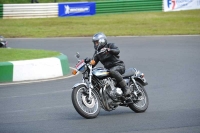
[{"left": 58, "top": 2, "right": 96, "bottom": 17}]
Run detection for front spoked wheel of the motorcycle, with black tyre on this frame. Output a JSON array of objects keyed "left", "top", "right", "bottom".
[{"left": 72, "top": 85, "right": 100, "bottom": 119}]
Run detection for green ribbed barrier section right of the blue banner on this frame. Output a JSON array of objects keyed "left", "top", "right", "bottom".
[{"left": 96, "top": 0, "right": 162, "bottom": 14}]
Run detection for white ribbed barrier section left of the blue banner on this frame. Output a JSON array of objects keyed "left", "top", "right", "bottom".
[{"left": 0, "top": 3, "right": 58, "bottom": 19}]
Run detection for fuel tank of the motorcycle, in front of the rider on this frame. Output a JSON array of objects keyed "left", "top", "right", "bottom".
[{"left": 92, "top": 67, "right": 109, "bottom": 79}]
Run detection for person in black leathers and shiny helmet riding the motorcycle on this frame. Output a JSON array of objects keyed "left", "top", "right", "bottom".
[{"left": 92, "top": 33, "right": 131, "bottom": 96}]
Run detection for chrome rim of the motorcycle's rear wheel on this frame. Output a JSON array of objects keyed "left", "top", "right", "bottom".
[{"left": 131, "top": 85, "right": 147, "bottom": 108}]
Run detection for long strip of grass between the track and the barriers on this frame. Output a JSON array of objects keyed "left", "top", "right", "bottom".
[{"left": 0, "top": 10, "right": 200, "bottom": 38}]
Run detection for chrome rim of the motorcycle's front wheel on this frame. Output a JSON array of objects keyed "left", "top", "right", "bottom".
[{"left": 76, "top": 87, "right": 99, "bottom": 114}]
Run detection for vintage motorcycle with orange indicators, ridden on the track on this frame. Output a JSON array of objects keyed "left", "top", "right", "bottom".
[{"left": 71, "top": 52, "right": 149, "bottom": 119}]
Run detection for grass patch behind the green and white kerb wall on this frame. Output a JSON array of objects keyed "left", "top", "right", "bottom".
[{"left": 0, "top": 48, "right": 60, "bottom": 62}]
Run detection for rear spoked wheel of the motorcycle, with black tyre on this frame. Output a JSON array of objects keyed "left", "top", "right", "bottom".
[{"left": 128, "top": 82, "right": 149, "bottom": 113}]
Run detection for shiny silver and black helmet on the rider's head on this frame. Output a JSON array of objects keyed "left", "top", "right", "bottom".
[{"left": 92, "top": 32, "right": 107, "bottom": 50}]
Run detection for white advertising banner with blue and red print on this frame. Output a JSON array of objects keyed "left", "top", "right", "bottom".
[{"left": 163, "top": 0, "right": 200, "bottom": 12}]
